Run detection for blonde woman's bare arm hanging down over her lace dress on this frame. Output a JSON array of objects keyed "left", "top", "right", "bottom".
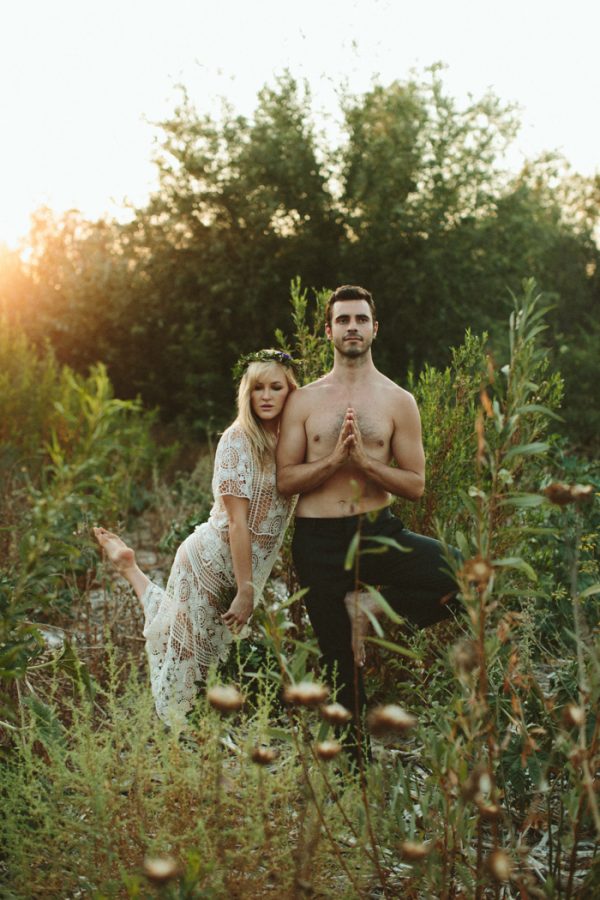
[{"left": 221, "top": 494, "right": 254, "bottom": 631}]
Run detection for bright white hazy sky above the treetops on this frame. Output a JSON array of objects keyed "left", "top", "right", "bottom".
[{"left": 0, "top": 0, "right": 600, "bottom": 245}]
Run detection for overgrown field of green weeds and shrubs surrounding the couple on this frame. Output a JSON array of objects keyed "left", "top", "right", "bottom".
[{"left": 0, "top": 282, "right": 600, "bottom": 900}]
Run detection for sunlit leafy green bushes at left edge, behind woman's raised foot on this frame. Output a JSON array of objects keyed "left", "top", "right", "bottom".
[{"left": 0, "top": 323, "right": 157, "bottom": 717}]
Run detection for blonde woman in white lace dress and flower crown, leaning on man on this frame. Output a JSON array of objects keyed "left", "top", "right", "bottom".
[{"left": 94, "top": 350, "right": 297, "bottom": 725}]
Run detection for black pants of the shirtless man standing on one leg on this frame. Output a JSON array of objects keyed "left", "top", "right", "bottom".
[{"left": 292, "top": 509, "right": 457, "bottom": 752}]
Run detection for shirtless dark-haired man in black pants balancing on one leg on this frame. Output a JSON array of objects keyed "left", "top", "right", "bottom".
[{"left": 277, "top": 285, "right": 456, "bottom": 748}]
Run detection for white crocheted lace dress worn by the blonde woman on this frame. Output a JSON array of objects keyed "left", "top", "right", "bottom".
[{"left": 142, "top": 423, "right": 294, "bottom": 725}]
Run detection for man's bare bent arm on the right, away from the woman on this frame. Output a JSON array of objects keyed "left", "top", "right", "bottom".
[{"left": 350, "top": 394, "right": 425, "bottom": 500}]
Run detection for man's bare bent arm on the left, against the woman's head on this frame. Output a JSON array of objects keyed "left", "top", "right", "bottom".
[{"left": 277, "top": 391, "right": 353, "bottom": 497}]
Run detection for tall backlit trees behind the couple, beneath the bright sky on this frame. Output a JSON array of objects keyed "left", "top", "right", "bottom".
[{"left": 5, "top": 66, "right": 600, "bottom": 447}]
